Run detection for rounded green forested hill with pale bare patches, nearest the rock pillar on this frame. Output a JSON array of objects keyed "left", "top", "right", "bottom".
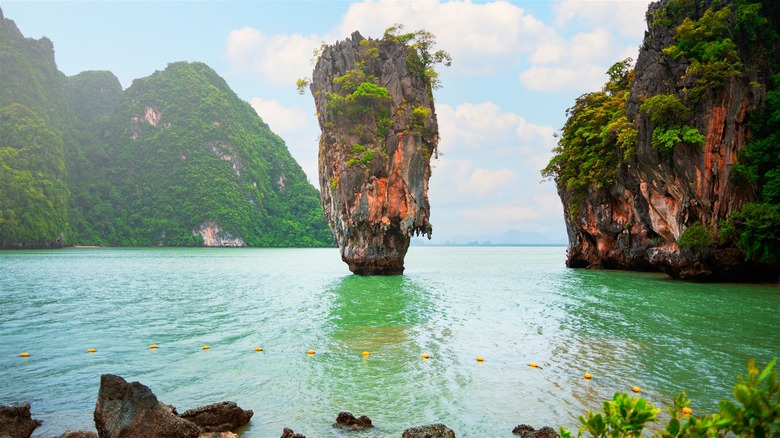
[{"left": 69, "top": 62, "right": 331, "bottom": 246}]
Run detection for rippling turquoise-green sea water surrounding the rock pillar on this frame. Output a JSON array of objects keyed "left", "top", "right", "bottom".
[{"left": 0, "top": 247, "right": 780, "bottom": 438}]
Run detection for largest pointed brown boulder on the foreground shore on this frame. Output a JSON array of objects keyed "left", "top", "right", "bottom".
[{"left": 94, "top": 374, "right": 203, "bottom": 438}]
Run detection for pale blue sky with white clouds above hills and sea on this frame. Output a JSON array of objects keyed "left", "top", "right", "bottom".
[{"left": 0, "top": 0, "right": 650, "bottom": 244}]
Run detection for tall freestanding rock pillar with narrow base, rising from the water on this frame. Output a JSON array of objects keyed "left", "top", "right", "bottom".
[{"left": 311, "top": 32, "right": 438, "bottom": 275}]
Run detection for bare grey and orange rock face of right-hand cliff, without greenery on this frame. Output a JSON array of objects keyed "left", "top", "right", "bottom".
[{"left": 559, "top": 0, "right": 780, "bottom": 281}]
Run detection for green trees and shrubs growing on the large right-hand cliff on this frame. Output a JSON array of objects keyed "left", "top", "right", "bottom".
[{"left": 542, "top": 0, "right": 780, "bottom": 263}]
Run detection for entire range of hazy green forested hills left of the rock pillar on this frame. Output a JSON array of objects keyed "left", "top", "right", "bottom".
[{"left": 0, "top": 11, "right": 333, "bottom": 247}]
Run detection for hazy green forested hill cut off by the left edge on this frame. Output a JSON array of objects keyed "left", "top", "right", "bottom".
[{"left": 0, "top": 11, "right": 74, "bottom": 248}]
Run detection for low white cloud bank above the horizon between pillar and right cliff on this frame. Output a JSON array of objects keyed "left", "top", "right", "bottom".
[{"left": 429, "top": 102, "right": 564, "bottom": 241}]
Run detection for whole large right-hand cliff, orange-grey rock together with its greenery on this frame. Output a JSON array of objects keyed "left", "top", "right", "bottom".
[{"left": 543, "top": 0, "right": 780, "bottom": 282}]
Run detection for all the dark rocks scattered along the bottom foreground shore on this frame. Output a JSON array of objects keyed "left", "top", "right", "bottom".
[{"left": 0, "top": 374, "right": 558, "bottom": 438}]
